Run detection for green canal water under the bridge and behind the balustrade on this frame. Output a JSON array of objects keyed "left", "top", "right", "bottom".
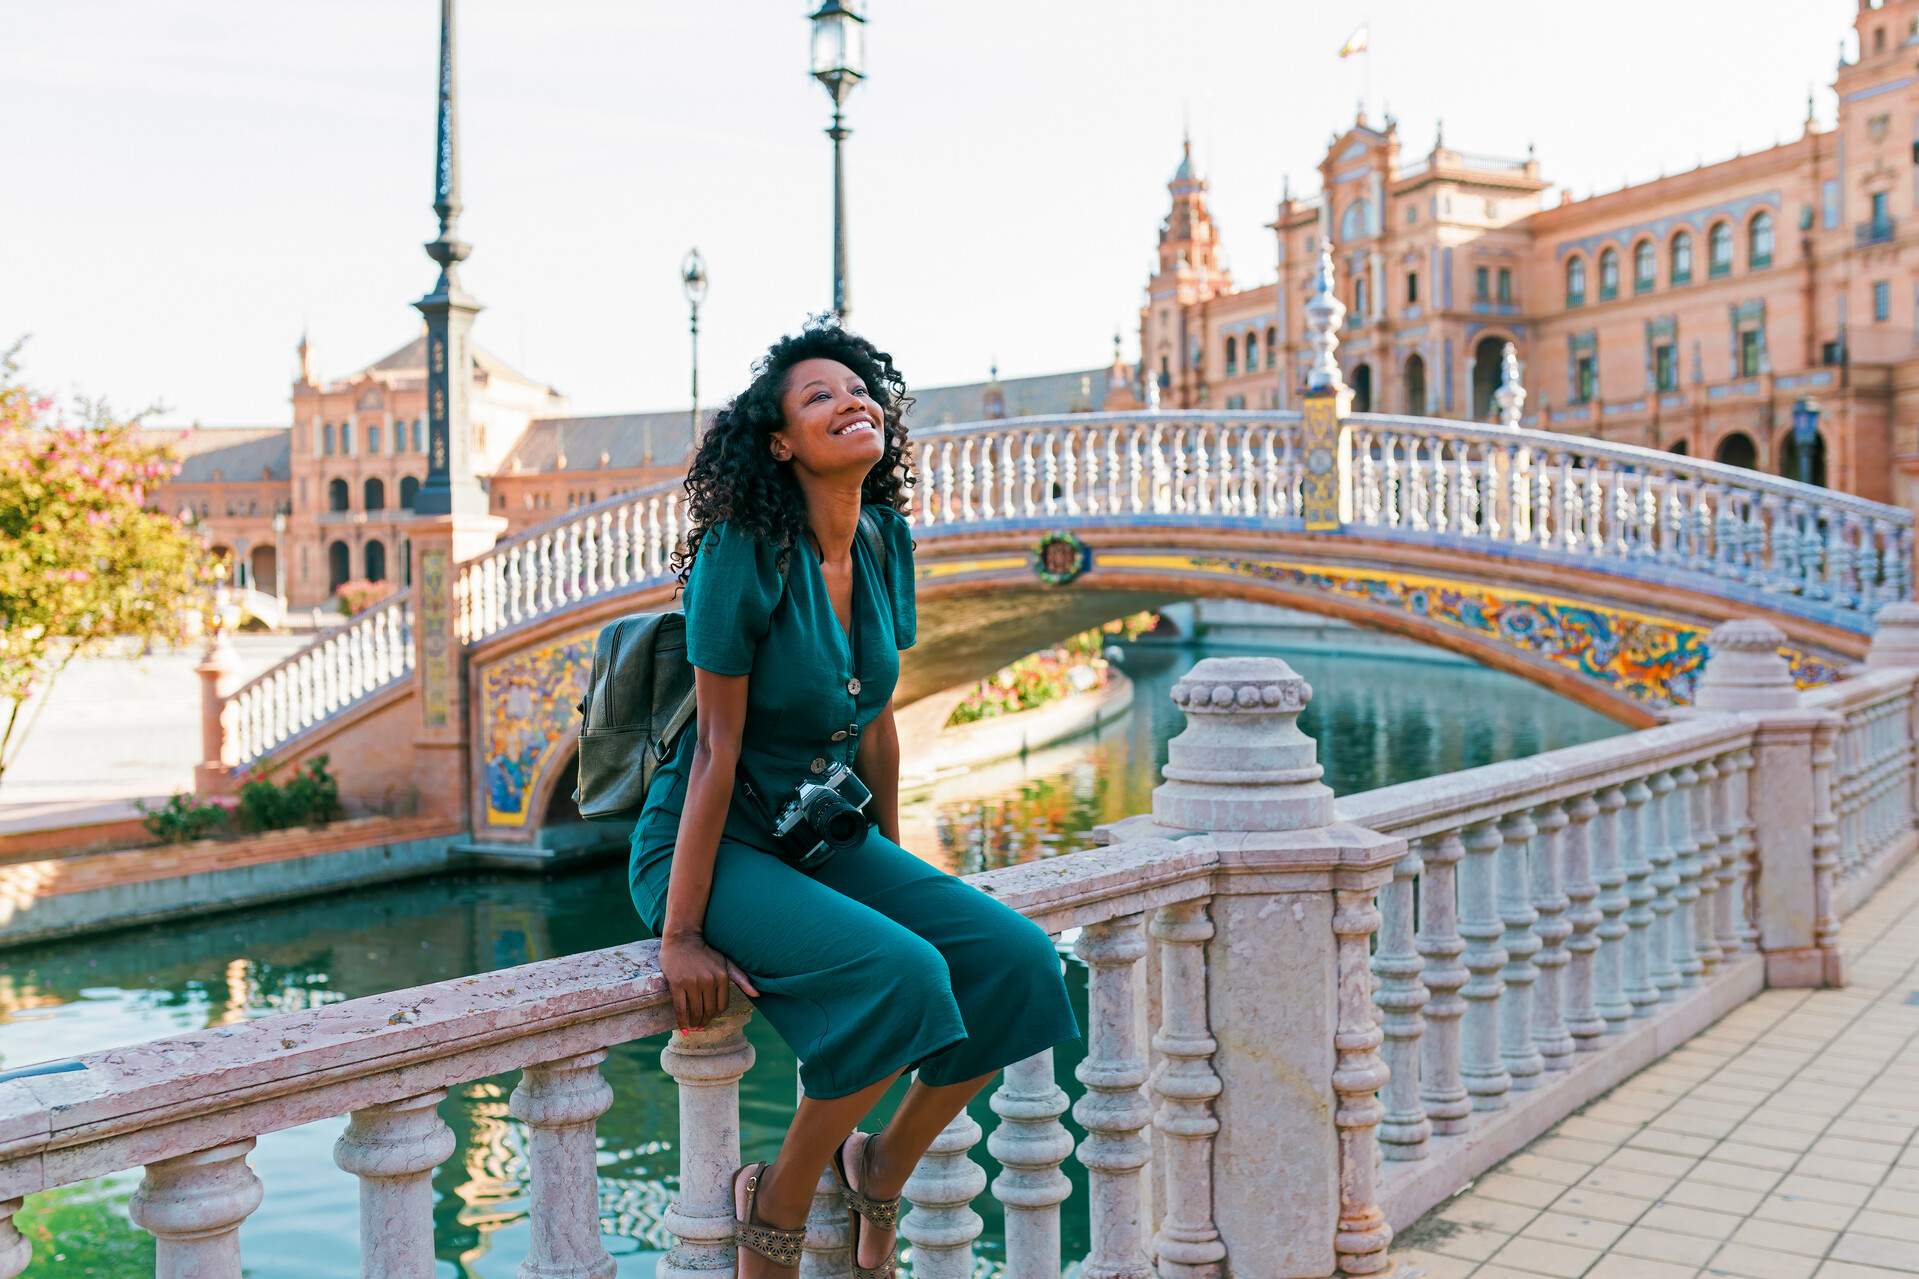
[{"left": 0, "top": 647, "right": 1622, "bottom": 1279}]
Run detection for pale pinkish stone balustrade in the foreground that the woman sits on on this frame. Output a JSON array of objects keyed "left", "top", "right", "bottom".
[{"left": 63, "top": 605, "right": 1919, "bottom": 1279}]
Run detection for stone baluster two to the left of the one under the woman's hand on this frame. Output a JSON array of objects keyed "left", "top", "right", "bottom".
[{"left": 334, "top": 1089, "right": 453, "bottom": 1279}]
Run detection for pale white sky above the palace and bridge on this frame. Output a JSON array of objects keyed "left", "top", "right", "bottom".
[{"left": 0, "top": 0, "right": 1856, "bottom": 424}]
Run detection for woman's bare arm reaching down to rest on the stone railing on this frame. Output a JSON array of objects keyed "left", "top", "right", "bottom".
[{"left": 660, "top": 666, "right": 760, "bottom": 1029}]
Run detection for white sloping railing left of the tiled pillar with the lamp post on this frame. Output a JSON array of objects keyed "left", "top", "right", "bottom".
[{"left": 221, "top": 591, "right": 415, "bottom": 768}]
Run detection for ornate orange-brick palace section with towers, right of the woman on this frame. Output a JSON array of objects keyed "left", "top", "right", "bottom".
[{"left": 1140, "top": 0, "right": 1919, "bottom": 505}]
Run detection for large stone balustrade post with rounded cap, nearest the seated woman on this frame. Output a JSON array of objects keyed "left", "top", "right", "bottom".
[{"left": 1153, "top": 657, "right": 1407, "bottom": 1279}]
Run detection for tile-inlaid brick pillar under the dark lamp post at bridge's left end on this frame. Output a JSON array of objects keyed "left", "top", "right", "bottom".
[{"left": 411, "top": 515, "right": 507, "bottom": 818}]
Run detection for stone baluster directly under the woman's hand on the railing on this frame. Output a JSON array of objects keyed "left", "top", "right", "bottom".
[{"left": 660, "top": 1001, "right": 752, "bottom": 1279}]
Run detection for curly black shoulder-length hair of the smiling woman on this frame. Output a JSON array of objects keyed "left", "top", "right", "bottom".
[{"left": 672, "top": 315, "right": 913, "bottom": 584}]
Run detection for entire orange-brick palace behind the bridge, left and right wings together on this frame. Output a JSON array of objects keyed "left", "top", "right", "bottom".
[{"left": 155, "top": 0, "right": 1919, "bottom": 607}]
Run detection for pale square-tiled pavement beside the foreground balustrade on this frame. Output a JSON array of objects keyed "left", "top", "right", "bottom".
[{"left": 1393, "top": 844, "right": 1919, "bottom": 1279}]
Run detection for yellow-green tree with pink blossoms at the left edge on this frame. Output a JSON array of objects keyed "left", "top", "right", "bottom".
[{"left": 0, "top": 346, "right": 219, "bottom": 780}]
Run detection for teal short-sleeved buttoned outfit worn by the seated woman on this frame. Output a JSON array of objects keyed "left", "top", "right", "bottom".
[{"left": 629, "top": 505, "right": 1078, "bottom": 1098}]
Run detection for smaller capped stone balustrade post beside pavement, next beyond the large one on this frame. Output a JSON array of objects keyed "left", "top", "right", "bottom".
[{"left": 1693, "top": 618, "right": 1844, "bottom": 987}]
